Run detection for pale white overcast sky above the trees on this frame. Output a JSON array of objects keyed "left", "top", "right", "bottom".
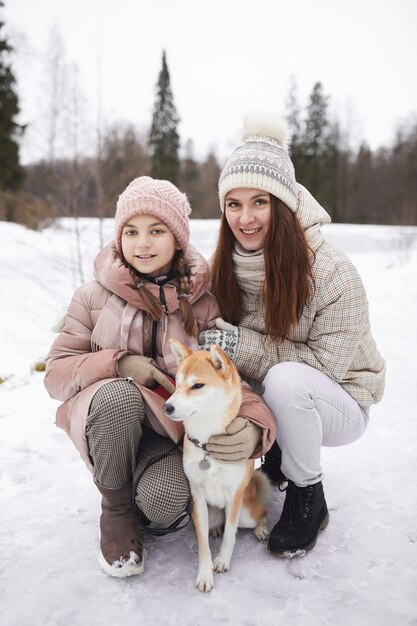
[{"left": 2, "top": 0, "right": 417, "bottom": 162}]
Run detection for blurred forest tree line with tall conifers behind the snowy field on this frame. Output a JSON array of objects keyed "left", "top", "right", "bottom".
[{"left": 0, "top": 5, "right": 417, "bottom": 228}]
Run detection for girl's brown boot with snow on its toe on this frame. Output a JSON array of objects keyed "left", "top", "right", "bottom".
[{"left": 97, "top": 485, "right": 145, "bottom": 578}]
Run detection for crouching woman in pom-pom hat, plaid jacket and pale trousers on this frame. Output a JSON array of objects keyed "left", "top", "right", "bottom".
[{"left": 199, "top": 114, "right": 385, "bottom": 556}]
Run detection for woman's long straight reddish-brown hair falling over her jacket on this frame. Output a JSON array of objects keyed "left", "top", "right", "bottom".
[{"left": 211, "top": 194, "right": 314, "bottom": 341}]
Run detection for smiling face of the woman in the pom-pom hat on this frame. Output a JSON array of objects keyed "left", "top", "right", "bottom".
[{"left": 225, "top": 187, "right": 271, "bottom": 251}]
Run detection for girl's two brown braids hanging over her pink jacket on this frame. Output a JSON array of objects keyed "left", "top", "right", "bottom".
[{"left": 130, "top": 250, "right": 198, "bottom": 337}]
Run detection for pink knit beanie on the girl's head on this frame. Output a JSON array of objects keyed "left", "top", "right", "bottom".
[{"left": 114, "top": 176, "right": 191, "bottom": 254}]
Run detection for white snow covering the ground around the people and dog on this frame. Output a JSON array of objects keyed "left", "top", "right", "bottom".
[{"left": 0, "top": 219, "right": 417, "bottom": 626}]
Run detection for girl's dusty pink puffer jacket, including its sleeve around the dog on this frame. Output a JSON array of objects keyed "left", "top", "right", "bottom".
[{"left": 45, "top": 244, "right": 275, "bottom": 472}]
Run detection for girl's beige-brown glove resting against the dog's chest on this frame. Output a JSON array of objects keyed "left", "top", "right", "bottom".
[{"left": 206, "top": 417, "right": 262, "bottom": 462}]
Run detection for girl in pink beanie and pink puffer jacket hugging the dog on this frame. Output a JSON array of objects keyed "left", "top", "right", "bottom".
[{"left": 45, "top": 176, "right": 275, "bottom": 577}]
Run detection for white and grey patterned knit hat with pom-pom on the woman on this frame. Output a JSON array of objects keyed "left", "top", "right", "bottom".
[{"left": 219, "top": 112, "right": 297, "bottom": 213}]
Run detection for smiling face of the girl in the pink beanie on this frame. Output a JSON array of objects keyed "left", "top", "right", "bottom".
[{"left": 121, "top": 215, "right": 180, "bottom": 278}]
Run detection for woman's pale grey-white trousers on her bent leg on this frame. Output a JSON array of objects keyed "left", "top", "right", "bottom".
[{"left": 264, "top": 362, "right": 369, "bottom": 487}]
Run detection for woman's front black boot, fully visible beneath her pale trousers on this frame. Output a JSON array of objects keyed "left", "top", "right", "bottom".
[{"left": 268, "top": 481, "right": 329, "bottom": 557}]
